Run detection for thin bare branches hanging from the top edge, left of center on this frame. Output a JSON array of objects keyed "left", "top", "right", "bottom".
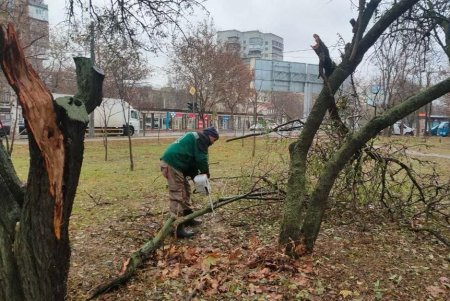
[{"left": 67, "top": 0, "right": 203, "bottom": 52}]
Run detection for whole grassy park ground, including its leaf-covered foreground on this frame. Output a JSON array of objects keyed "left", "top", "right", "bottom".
[{"left": 7, "top": 138, "right": 450, "bottom": 301}]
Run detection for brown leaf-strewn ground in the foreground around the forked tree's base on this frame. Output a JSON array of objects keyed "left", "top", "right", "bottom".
[{"left": 68, "top": 203, "right": 450, "bottom": 301}]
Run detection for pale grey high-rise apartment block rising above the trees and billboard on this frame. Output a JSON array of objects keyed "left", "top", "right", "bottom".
[{"left": 217, "top": 30, "right": 284, "bottom": 61}]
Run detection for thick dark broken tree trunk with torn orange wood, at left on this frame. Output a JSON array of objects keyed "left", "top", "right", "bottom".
[{"left": 0, "top": 25, "right": 103, "bottom": 301}]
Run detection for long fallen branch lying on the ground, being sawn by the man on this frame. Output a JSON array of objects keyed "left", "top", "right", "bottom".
[{"left": 87, "top": 191, "right": 272, "bottom": 300}]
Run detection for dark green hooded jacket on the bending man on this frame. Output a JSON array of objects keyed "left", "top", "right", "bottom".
[{"left": 161, "top": 132, "right": 211, "bottom": 179}]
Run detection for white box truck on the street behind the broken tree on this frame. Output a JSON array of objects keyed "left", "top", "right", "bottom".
[{"left": 53, "top": 94, "right": 140, "bottom": 136}]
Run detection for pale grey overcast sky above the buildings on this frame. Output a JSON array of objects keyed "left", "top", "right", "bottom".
[{"left": 45, "top": 0, "right": 357, "bottom": 85}]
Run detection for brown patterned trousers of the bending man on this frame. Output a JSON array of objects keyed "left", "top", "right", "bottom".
[{"left": 160, "top": 160, "right": 192, "bottom": 217}]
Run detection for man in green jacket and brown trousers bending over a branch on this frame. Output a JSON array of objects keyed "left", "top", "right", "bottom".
[{"left": 160, "top": 127, "right": 219, "bottom": 238}]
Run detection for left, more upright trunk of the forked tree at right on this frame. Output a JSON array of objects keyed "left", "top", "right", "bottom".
[{"left": 279, "top": 0, "right": 418, "bottom": 257}]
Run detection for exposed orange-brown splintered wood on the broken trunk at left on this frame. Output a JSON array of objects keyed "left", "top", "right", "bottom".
[{"left": 0, "top": 24, "right": 64, "bottom": 239}]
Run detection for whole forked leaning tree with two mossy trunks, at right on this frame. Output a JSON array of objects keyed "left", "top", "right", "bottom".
[{"left": 279, "top": 0, "right": 450, "bottom": 257}]
